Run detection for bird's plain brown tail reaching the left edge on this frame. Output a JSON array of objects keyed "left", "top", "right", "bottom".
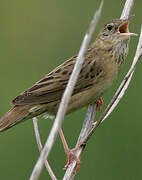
[{"left": 0, "top": 106, "right": 30, "bottom": 131}]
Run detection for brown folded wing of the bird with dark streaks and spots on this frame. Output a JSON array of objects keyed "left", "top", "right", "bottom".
[{"left": 12, "top": 49, "right": 102, "bottom": 105}]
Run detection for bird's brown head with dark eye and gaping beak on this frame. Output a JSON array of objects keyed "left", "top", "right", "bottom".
[{"left": 97, "top": 16, "right": 137, "bottom": 45}]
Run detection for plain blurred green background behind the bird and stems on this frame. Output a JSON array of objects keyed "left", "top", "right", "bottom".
[{"left": 0, "top": 0, "right": 142, "bottom": 180}]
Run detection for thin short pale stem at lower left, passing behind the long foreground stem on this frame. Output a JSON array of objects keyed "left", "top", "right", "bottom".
[{"left": 33, "top": 117, "right": 57, "bottom": 180}]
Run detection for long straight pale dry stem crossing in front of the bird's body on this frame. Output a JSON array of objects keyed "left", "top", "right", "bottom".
[{"left": 30, "top": 1, "right": 103, "bottom": 180}]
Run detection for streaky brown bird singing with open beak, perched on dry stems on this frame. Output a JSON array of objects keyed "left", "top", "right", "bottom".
[{"left": 0, "top": 17, "right": 136, "bottom": 171}]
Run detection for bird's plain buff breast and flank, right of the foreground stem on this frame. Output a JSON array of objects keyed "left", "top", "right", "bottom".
[{"left": 67, "top": 58, "right": 118, "bottom": 113}]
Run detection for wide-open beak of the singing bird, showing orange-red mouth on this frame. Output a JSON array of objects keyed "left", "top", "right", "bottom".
[{"left": 118, "top": 16, "right": 138, "bottom": 37}]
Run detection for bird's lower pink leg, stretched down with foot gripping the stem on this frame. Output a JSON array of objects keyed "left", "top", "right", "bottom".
[{"left": 59, "top": 128, "right": 81, "bottom": 172}]
